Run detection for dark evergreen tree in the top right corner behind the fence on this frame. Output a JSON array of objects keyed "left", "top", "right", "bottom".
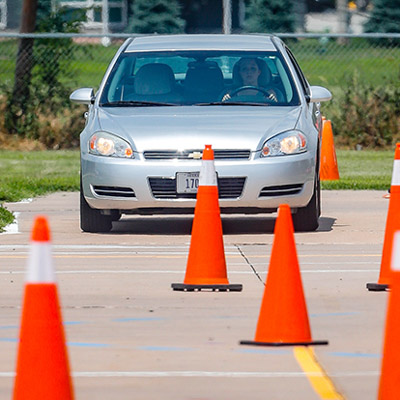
[{"left": 364, "top": 0, "right": 400, "bottom": 33}]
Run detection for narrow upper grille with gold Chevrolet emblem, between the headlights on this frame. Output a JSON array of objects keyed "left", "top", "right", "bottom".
[{"left": 143, "top": 150, "right": 251, "bottom": 160}]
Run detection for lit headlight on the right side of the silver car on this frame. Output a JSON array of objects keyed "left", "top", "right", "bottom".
[{"left": 261, "top": 131, "right": 307, "bottom": 157}]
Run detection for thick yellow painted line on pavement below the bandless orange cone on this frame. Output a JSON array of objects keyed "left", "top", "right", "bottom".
[{"left": 293, "top": 346, "right": 345, "bottom": 400}]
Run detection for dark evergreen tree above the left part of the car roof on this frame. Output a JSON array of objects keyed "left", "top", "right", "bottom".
[{"left": 126, "top": 0, "right": 185, "bottom": 33}]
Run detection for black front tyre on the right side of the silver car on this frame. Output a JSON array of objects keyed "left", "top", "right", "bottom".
[{"left": 293, "top": 174, "right": 321, "bottom": 232}]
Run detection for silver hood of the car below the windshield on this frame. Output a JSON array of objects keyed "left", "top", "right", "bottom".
[{"left": 97, "top": 106, "right": 301, "bottom": 152}]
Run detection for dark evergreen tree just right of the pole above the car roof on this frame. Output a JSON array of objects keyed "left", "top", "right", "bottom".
[{"left": 245, "top": 0, "right": 295, "bottom": 33}]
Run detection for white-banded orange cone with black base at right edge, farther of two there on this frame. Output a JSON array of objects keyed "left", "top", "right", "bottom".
[{"left": 367, "top": 143, "right": 400, "bottom": 292}]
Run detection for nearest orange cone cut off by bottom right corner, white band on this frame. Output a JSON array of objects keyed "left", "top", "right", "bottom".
[{"left": 378, "top": 231, "right": 400, "bottom": 400}]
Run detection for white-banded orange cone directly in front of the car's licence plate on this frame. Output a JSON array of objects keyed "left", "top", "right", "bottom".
[{"left": 171, "top": 145, "right": 242, "bottom": 291}]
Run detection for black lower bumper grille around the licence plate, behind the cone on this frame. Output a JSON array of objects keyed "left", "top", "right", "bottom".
[{"left": 149, "top": 177, "right": 246, "bottom": 199}]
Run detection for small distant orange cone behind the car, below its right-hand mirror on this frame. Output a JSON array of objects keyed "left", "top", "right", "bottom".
[{"left": 319, "top": 119, "right": 339, "bottom": 181}]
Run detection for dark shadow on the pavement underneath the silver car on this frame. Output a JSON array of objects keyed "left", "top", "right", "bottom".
[{"left": 110, "top": 215, "right": 336, "bottom": 235}]
